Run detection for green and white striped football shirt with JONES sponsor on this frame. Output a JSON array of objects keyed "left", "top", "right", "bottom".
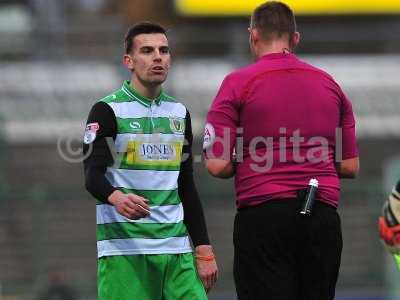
[{"left": 96, "top": 81, "right": 192, "bottom": 257}]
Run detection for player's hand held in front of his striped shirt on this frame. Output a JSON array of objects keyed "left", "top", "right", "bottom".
[{"left": 108, "top": 190, "right": 150, "bottom": 220}]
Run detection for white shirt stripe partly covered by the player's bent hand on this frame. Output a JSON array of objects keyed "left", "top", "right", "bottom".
[{"left": 96, "top": 203, "right": 183, "bottom": 225}]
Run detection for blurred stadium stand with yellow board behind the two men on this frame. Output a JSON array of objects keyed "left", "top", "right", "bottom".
[{"left": 0, "top": 0, "right": 400, "bottom": 300}]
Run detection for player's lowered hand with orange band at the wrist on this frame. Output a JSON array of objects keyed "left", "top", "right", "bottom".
[{"left": 195, "top": 245, "right": 218, "bottom": 293}]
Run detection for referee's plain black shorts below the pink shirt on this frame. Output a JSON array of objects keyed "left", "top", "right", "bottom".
[{"left": 233, "top": 199, "right": 342, "bottom": 300}]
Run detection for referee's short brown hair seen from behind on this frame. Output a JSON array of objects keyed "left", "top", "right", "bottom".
[{"left": 250, "top": 1, "right": 296, "bottom": 41}]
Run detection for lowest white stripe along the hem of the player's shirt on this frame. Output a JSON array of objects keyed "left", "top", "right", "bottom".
[{"left": 97, "top": 236, "right": 192, "bottom": 258}]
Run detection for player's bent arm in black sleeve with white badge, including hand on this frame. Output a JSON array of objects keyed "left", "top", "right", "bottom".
[{"left": 83, "top": 102, "right": 149, "bottom": 219}]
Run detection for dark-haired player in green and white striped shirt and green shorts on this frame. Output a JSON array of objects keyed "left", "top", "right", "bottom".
[{"left": 84, "top": 22, "right": 217, "bottom": 300}]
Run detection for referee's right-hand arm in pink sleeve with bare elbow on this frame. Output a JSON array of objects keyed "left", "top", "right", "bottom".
[{"left": 336, "top": 89, "right": 360, "bottom": 178}]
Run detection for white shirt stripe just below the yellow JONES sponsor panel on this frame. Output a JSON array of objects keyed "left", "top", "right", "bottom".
[{"left": 106, "top": 168, "right": 179, "bottom": 191}]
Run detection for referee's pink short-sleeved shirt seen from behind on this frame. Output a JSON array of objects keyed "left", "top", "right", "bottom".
[{"left": 204, "top": 53, "right": 358, "bottom": 208}]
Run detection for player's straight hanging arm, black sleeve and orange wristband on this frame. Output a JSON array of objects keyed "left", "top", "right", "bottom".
[{"left": 178, "top": 112, "right": 218, "bottom": 291}]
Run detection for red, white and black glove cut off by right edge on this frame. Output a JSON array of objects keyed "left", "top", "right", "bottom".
[{"left": 379, "top": 180, "right": 400, "bottom": 270}]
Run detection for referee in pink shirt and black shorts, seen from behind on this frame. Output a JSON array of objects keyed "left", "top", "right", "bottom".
[{"left": 203, "top": 1, "right": 359, "bottom": 300}]
